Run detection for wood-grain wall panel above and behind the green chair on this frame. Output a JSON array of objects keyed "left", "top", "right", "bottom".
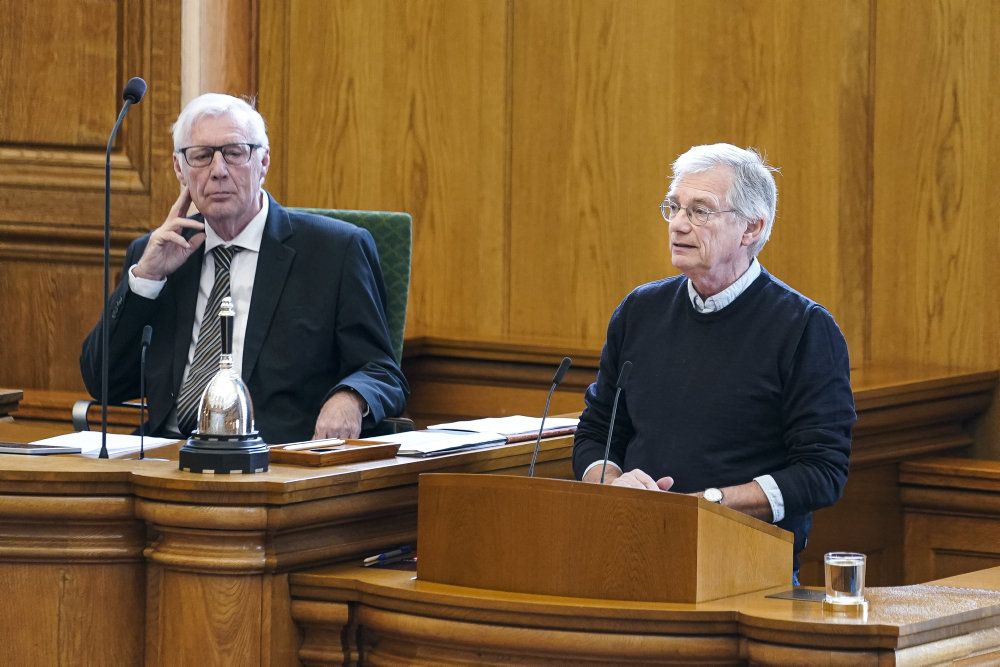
[{"left": 259, "top": 0, "right": 508, "bottom": 339}]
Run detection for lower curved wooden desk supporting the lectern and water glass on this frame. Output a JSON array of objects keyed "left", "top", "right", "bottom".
[{"left": 291, "top": 564, "right": 1000, "bottom": 666}]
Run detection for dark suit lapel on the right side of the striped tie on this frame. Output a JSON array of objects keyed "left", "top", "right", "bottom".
[{"left": 243, "top": 195, "right": 295, "bottom": 382}]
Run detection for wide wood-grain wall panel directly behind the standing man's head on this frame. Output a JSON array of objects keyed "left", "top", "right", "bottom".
[{"left": 510, "top": 0, "right": 869, "bottom": 359}]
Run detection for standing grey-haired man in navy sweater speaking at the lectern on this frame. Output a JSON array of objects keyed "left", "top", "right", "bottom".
[{"left": 573, "top": 144, "right": 857, "bottom": 571}]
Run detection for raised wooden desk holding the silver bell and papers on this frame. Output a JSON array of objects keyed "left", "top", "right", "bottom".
[{"left": 0, "top": 437, "right": 572, "bottom": 665}]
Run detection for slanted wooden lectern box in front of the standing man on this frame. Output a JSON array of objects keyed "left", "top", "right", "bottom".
[{"left": 417, "top": 474, "right": 793, "bottom": 603}]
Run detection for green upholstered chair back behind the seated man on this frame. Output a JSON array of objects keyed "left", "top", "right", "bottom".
[{"left": 295, "top": 208, "right": 413, "bottom": 363}]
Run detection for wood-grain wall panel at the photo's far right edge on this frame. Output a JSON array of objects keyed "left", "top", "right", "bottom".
[{"left": 871, "top": 0, "right": 1000, "bottom": 368}]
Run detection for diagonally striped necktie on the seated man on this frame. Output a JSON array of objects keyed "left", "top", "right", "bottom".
[{"left": 177, "top": 245, "right": 240, "bottom": 435}]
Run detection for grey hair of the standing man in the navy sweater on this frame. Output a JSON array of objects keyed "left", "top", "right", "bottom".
[{"left": 670, "top": 144, "right": 778, "bottom": 257}]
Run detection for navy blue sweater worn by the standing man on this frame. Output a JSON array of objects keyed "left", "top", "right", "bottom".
[{"left": 573, "top": 271, "right": 856, "bottom": 562}]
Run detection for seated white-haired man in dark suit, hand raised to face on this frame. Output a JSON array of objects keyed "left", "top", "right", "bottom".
[{"left": 80, "top": 93, "right": 408, "bottom": 443}]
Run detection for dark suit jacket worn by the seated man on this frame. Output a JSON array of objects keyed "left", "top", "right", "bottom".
[{"left": 80, "top": 195, "right": 409, "bottom": 443}]
